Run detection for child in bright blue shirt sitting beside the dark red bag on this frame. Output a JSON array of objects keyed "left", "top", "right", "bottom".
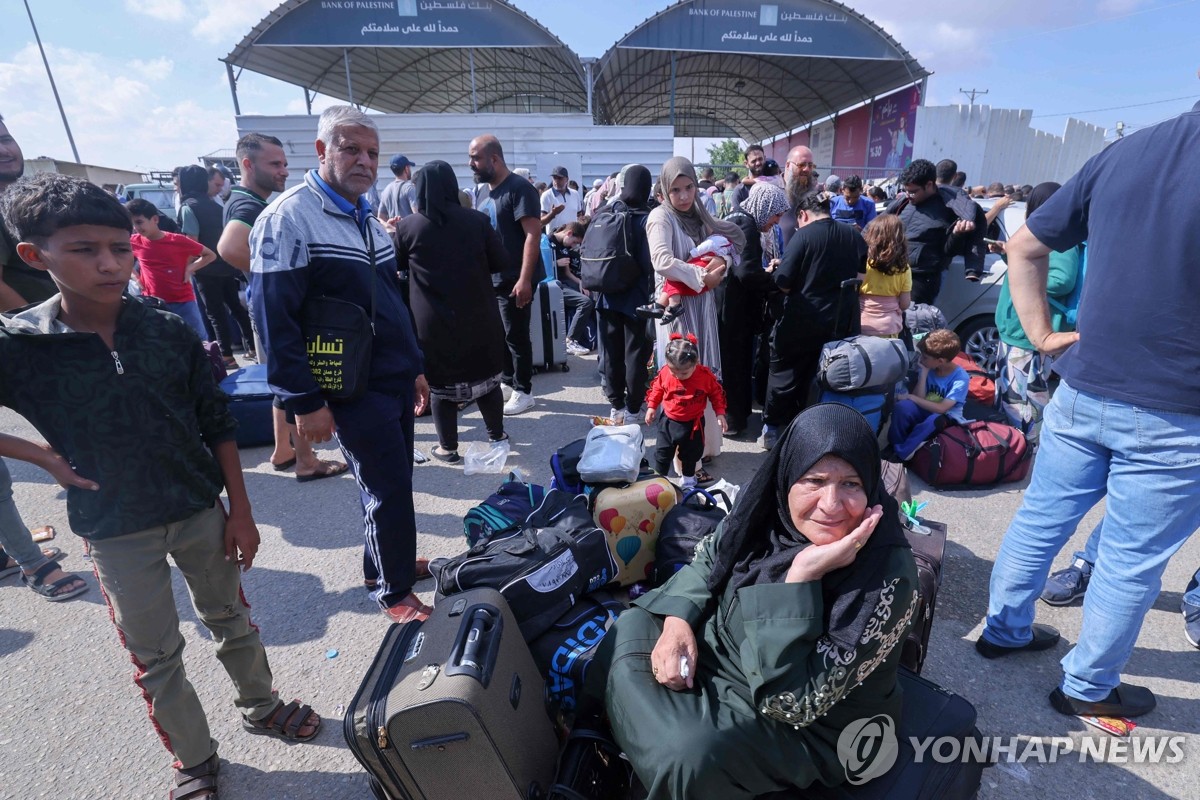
[{"left": 888, "top": 329, "right": 971, "bottom": 461}]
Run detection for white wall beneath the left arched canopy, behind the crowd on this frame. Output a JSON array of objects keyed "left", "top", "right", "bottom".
[{"left": 229, "top": 114, "right": 674, "bottom": 191}]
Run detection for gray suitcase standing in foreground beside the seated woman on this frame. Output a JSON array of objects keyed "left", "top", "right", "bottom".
[{"left": 343, "top": 589, "right": 558, "bottom": 800}]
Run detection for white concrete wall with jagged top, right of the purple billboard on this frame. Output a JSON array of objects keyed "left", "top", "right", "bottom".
[{"left": 913, "top": 106, "right": 1104, "bottom": 186}]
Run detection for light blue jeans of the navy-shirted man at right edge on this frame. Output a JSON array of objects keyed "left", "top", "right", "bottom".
[{"left": 983, "top": 381, "right": 1200, "bottom": 700}]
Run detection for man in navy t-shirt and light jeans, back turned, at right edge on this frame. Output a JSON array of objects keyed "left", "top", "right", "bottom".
[{"left": 976, "top": 98, "right": 1200, "bottom": 717}]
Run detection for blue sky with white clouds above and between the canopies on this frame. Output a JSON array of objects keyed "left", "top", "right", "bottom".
[{"left": 0, "top": 0, "right": 1200, "bottom": 170}]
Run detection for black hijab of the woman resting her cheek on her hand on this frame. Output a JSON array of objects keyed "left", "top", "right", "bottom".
[{"left": 708, "top": 403, "right": 908, "bottom": 650}]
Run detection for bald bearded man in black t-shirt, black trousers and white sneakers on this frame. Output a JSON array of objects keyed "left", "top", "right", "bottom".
[{"left": 464, "top": 134, "right": 546, "bottom": 415}]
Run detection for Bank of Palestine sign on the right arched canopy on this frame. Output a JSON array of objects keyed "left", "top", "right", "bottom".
[{"left": 618, "top": 0, "right": 904, "bottom": 60}]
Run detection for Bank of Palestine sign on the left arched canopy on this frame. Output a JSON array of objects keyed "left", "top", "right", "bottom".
[{"left": 254, "top": 0, "right": 559, "bottom": 48}]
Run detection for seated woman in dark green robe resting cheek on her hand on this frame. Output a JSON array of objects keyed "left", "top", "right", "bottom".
[{"left": 596, "top": 403, "right": 918, "bottom": 800}]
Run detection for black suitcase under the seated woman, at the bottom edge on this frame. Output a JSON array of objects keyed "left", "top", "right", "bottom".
[{"left": 801, "top": 668, "right": 989, "bottom": 800}]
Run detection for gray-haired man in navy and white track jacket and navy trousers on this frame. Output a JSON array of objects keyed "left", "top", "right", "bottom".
[{"left": 250, "top": 106, "right": 431, "bottom": 622}]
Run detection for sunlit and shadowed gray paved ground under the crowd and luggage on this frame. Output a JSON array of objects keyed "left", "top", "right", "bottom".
[{"left": 0, "top": 357, "right": 1200, "bottom": 800}]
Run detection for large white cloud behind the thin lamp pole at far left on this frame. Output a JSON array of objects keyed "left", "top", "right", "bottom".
[{"left": 0, "top": 44, "right": 236, "bottom": 172}]
